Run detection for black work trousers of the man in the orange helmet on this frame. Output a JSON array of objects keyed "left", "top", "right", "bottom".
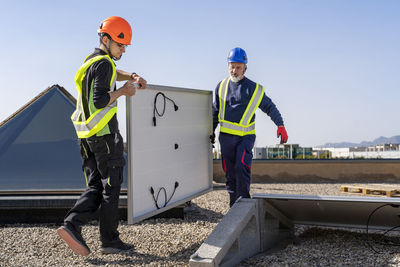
[{"left": 64, "top": 133, "right": 125, "bottom": 245}]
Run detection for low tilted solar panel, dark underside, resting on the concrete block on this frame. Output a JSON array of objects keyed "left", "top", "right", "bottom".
[{"left": 253, "top": 194, "right": 400, "bottom": 229}]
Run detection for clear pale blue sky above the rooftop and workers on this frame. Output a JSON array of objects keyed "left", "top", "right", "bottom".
[{"left": 0, "top": 0, "right": 400, "bottom": 146}]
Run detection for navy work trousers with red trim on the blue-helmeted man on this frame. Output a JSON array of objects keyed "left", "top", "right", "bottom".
[{"left": 219, "top": 133, "right": 256, "bottom": 207}]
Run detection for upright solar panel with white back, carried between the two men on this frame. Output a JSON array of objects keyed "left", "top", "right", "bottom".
[{"left": 126, "top": 85, "right": 212, "bottom": 223}]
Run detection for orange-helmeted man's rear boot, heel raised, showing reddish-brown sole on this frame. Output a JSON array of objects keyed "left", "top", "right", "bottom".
[{"left": 57, "top": 225, "right": 90, "bottom": 256}]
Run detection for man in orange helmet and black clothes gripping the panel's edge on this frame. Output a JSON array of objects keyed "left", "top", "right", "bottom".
[{"left": 57, "top": 16, "right": 146, "bottom": 256}]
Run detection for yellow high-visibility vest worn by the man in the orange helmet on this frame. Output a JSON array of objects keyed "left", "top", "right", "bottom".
[{"left": 71, "top": 55, "right": 117, "bottom": 138}]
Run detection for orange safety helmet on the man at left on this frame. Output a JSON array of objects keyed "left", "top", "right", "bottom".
[{"left": 97, "top": 16, "right": 132, "bottom": 45}]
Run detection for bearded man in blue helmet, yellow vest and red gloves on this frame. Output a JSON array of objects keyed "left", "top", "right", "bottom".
[{"left": 212, "top": 47, "right": 288, "bottom": 207}]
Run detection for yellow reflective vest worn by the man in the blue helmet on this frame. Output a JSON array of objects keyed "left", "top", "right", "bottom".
[{"left": 218, "top": 78, "right": 264, "bottom": 136}]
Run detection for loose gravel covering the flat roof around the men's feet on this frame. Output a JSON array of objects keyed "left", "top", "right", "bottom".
[{"left": 0, "top": 183, "right": 400, "bottom": 266}]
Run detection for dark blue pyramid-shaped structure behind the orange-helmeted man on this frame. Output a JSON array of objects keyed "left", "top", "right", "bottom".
[{"left": 0, "top": 88, "right": 86, "bottom": 194}]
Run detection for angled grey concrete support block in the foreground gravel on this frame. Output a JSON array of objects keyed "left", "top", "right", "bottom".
[{"left": 189, "top": 199, "right": 294, "bottom": 267}]
